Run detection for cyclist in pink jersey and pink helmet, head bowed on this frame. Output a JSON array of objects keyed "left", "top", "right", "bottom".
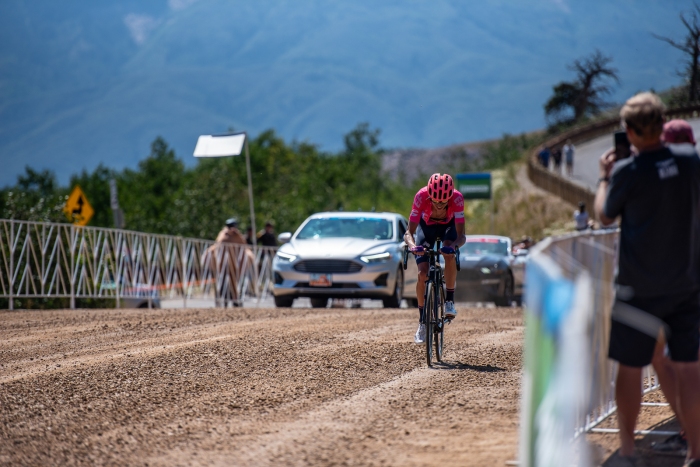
[{"left": 404, "top": 173, "right": 467, "bottom": 344}]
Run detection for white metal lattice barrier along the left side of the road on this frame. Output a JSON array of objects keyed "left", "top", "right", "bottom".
[{"left": 0, "top": 219, "right": 276, "bottom": 309}]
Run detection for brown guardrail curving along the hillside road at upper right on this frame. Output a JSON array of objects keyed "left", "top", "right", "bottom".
[{"left": 527, "top": 105, "right": 700, "bottom": 206}]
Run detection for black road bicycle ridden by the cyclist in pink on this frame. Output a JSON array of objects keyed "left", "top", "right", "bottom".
[{"left": 403, "top": 237, "right": 460, "bottom": 366}]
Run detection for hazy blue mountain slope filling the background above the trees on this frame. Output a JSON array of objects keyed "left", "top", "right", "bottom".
[{"left": 0, "top": 0, "right": 692, "bottom": 186}]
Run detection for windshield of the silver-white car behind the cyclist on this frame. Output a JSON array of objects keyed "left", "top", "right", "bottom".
[{"left": 297, "top": 217, "right": 394, "bottom": 240}]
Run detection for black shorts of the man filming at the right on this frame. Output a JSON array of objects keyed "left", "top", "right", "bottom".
[{"left": 608, "top": 291, "right": 700, "bottom": 367}]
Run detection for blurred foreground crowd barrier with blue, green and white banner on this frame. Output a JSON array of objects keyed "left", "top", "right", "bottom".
[{"left": 520, "top": 230, "right": 659, "bottom": 466}]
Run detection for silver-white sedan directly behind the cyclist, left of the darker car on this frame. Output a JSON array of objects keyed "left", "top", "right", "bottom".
[{"left": 272, "top": 212, "right": 418, "bottom": 308}]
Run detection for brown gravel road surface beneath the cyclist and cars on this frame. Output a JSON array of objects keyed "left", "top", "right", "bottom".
[{"left": 0, "top": 307, "right": 523, "bottom": 466}]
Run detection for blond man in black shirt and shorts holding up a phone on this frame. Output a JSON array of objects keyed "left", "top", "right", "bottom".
[{"left": 595, "top": 92, "right": 700, "bottom": 466}]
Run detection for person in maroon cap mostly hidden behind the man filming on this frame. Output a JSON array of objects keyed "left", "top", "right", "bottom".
[{"left": 651, "top": 120, "right": 695, "bottom": 455}]
